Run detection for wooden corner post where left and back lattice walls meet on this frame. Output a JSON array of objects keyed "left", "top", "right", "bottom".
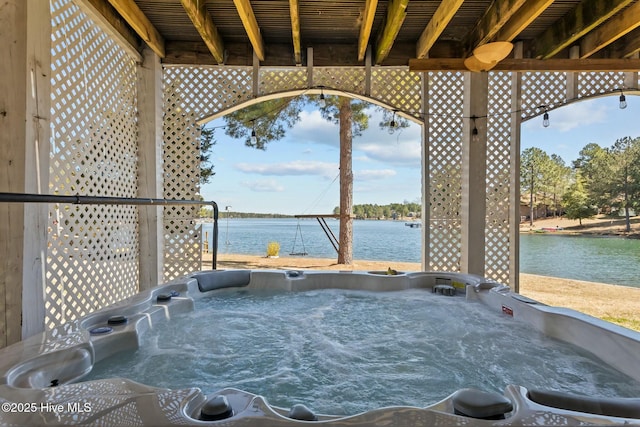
[{"left": 138, "top": 49, "right": 164, "bottom": 291}]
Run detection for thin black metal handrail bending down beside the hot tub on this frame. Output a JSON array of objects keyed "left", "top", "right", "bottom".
[{"left": 0, "top": 192, "right": 218, "bottom": 270}]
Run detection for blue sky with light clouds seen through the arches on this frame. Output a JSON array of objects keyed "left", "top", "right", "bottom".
[{"left": 201, "top": 94, "right": 640, "bottom": 215}]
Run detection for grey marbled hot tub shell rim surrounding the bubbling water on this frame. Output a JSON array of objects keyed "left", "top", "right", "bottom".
[{"left": 0, "top": 270, "right": 640, "bottom": 426}]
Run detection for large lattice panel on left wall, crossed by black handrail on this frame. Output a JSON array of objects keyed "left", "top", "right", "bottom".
[{"left": 45, "top": 0, "right": 138, "bottom": 329}]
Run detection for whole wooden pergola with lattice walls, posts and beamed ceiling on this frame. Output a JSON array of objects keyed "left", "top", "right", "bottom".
[{"left": 0, "top": 0, "right": 640, "bottom": 346}]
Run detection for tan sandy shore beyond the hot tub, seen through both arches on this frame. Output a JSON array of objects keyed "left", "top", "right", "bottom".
[{"left": 203, "top": 254, "right": 640, "bottom": 331}]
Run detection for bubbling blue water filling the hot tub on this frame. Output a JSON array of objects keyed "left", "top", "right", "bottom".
[{"left": 82, "top": 289, "right": 640, "bottom": 415}]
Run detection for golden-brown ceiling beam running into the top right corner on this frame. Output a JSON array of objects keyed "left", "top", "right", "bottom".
[{"left": 580, "top": 3, "right": 640, "bottom": 58}]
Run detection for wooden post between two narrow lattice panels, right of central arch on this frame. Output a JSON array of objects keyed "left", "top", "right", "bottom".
[{"left": 460, "top": 72, "right": 489, "bottom": 276}]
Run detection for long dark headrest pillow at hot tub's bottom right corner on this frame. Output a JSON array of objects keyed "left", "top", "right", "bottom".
[{"left": 527, "top": 390, "right": 640, "bottom": 419}]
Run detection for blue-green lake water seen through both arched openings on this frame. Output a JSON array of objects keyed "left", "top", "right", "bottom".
[{"left": 203, "top": 219, "right": 640, "bottom": 287}]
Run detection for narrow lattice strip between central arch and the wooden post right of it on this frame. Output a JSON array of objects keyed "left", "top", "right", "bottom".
[{"left": 425, "top": 73, "right": 464, "bottom": 271}]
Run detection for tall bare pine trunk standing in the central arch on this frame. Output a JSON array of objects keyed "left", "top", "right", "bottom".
[{"left": 338, "top": 97, "right": 353, "bottom": 264}]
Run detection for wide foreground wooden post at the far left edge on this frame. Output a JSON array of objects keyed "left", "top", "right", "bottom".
[{"left": 0, "top": 0, "right": 51, "bottom": 347}]
